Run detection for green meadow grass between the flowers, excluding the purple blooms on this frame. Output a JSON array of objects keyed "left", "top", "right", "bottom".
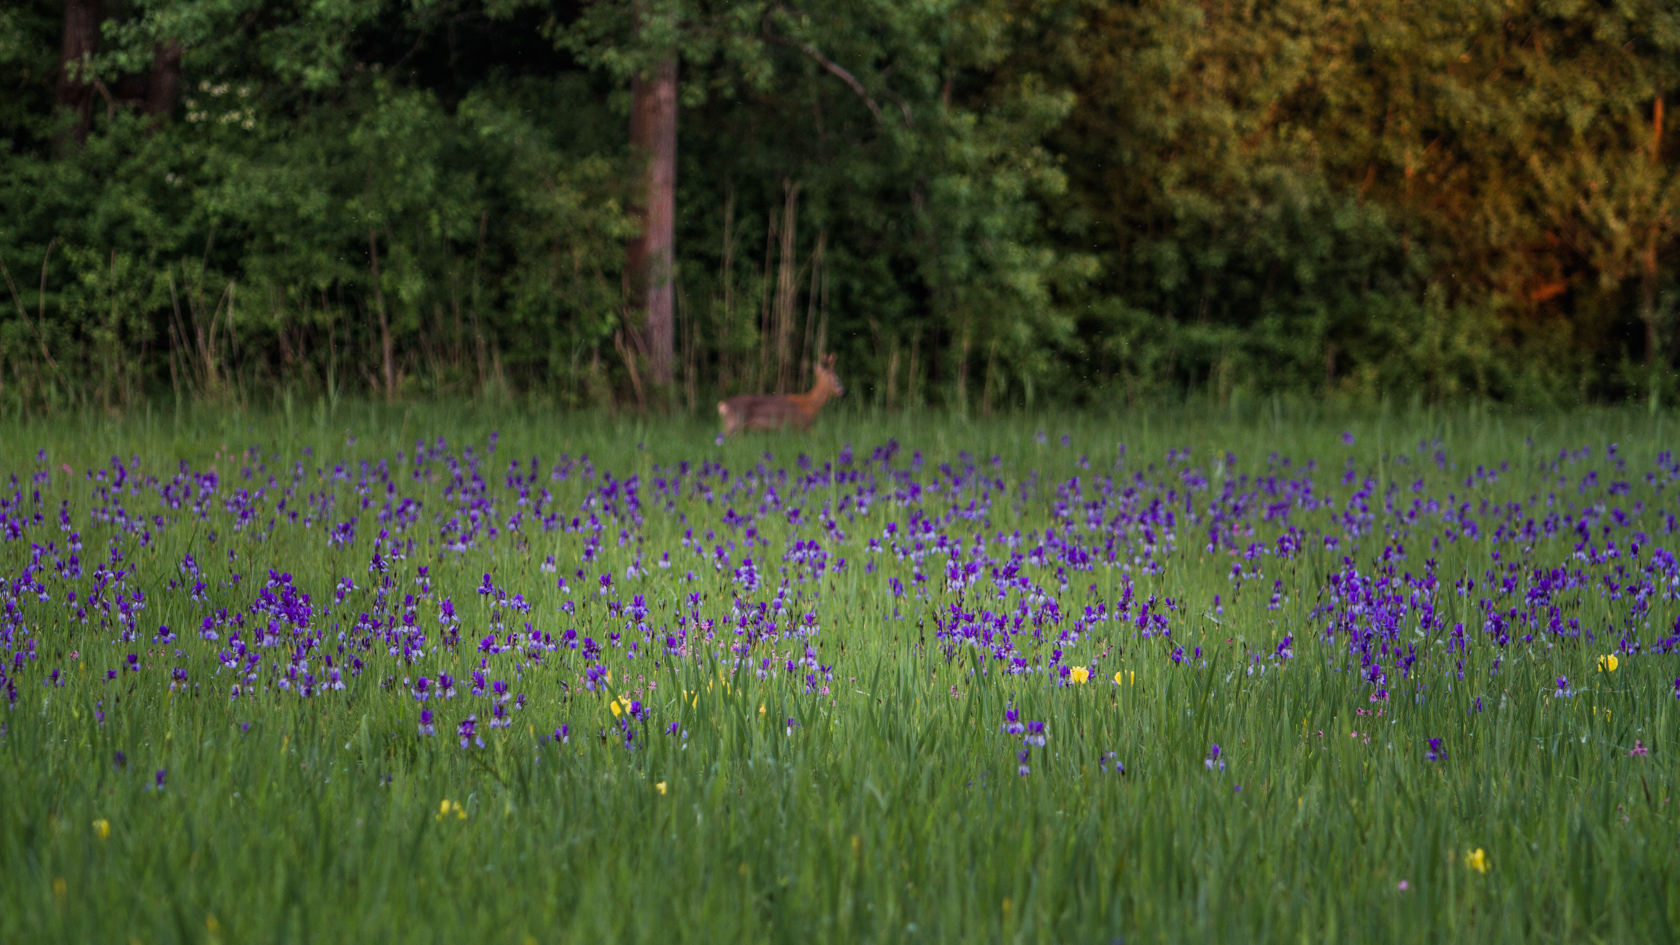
[{"left": 0, "top": 405, "right": 1680, "bottom": 943}]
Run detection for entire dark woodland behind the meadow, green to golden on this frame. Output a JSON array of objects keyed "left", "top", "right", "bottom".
[{"left": 0, "top": 0, "right": 1680, "bottom": 414}]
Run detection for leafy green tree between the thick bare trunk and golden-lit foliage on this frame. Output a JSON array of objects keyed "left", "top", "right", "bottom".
[{"left": 553, "top": 0, "right": 1082, "bottom": 400}]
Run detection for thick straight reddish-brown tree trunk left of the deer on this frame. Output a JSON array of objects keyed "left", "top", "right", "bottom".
[{"left": 625, "top": 59, "right": 677, "bottom": 387}]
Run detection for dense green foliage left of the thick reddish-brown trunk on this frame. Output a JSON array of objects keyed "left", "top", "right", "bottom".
[{"left": 0, "top": 5, "right": 627, "bottom": 404}]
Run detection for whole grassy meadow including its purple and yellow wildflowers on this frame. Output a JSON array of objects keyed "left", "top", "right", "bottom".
[{"left": 0, "top": 405, "right": 1680, "bottom": 943}]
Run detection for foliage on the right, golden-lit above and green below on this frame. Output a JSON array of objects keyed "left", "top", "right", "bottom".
[{"left": 1025, "top": 0, "right": 1680, "bottom": 399}]
